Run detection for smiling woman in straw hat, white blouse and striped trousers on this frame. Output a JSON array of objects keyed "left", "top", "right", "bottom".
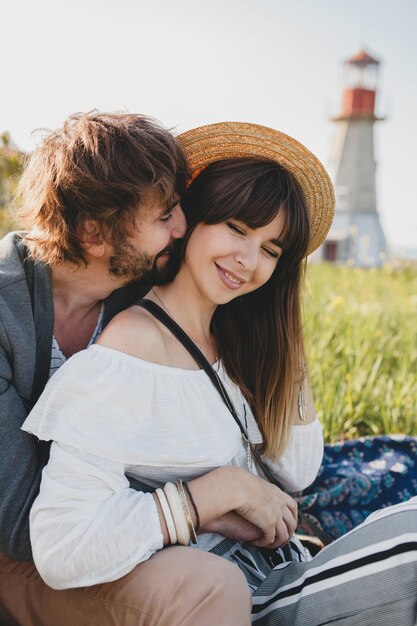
[{"left": 24, "top": 123, "right": 417, "bottom": 626}]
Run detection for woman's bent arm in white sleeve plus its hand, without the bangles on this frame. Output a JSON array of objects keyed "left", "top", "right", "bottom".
[{"left": 31, "top": 436, "right": 297, "bottom": 589}]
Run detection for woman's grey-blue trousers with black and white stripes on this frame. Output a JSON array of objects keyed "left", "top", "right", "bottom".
[{"left": 213, "top": 498, "right": 417, "bottom": 626}]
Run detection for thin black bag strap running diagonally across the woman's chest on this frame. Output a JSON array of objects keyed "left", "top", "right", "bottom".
[{"left": 135, "top": 298, "right": 333, "bottom": 545}]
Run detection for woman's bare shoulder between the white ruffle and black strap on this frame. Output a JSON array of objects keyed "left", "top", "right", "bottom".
[{"left": 97, "top": 306, "right": 166, "bottom": 364}]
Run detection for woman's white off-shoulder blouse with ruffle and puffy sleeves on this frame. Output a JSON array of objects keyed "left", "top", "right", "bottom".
[{"left": 22, "top": 345, "right": 323, "bottom": 589}]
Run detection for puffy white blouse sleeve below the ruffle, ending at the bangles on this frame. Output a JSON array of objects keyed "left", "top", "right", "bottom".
[{"left": 30, "top": 442, "right": 163, "bottom": 589}]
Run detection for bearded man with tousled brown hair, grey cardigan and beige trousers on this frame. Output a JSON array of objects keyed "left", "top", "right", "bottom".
[{"left": 0, "top": 112, "right": 249, "bottom": 626}]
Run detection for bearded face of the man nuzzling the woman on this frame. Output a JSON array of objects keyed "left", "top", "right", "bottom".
[{"left": 109, "top": 198, "right": 187, "bottom": 285}]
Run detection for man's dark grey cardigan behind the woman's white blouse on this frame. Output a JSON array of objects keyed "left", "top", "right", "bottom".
[{"left": 0, "top": 233, "right": 138, "bottom": 561}]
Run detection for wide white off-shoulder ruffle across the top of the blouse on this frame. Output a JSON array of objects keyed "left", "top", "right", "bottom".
[{"left": 23, "top": 345, "right": 240, "bottom": 467}]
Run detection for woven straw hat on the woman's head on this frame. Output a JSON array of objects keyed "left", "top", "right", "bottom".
[{"left": 178, "top": 122, "right": 335, "bottom": 254}]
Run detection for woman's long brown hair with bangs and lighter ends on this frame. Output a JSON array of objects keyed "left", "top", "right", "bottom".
[{"left": 181, "top": 159, "right": 310, "bottom": 458}]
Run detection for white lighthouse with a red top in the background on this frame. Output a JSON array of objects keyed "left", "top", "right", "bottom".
[{"left": 321, "top": 50, "right": 386, "bottom": 267}]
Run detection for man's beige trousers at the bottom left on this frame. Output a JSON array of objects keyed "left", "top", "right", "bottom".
[{"left": 0, "top": 546, "right": 251, "bottom": 626}]
